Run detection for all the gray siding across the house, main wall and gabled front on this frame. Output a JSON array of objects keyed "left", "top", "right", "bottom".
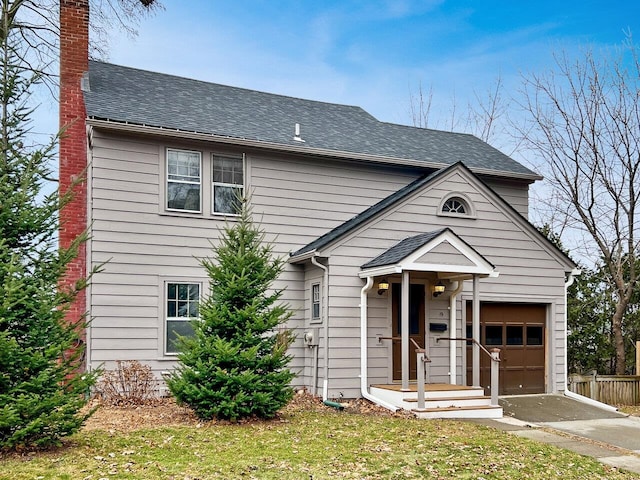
[{"left": 89, "top": 129, "right": 564, "bottom": 398}]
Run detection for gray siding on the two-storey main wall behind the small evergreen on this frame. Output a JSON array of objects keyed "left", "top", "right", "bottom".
[{"left": 89, "top": 129, "right": 417, "bottom": 385}]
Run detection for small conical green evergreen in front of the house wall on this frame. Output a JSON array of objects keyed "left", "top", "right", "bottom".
[{"left": 167, "top": 200, "right": 294, "bottom": 421}]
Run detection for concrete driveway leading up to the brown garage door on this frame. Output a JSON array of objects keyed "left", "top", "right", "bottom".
[{"left": 480, "top": 395, "right": 640, "bottom": 473}]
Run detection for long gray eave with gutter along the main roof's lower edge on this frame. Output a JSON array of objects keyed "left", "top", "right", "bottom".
[{"left": 87, "top": 117, "right": 543, "bottom": 182}]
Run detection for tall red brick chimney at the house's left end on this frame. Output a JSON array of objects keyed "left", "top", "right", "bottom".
[{"left": 59, "top": 0, "right": 89, "bottom": 339}]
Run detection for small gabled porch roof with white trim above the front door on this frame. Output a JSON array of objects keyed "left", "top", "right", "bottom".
[{"left": 360, "top": 227, "right": 498, "bottom": 278}]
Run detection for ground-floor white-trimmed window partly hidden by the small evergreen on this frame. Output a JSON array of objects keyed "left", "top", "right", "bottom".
[{"left": 165, "top": 282, "right": 200, "bottom": 354}]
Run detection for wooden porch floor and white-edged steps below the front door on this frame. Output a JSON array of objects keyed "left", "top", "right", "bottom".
[{"left": 369, "top": 382, "right": 502, "bottom": 419}]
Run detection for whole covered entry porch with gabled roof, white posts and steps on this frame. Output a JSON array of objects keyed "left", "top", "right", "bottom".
[{"left": 360, "top": 228, "right": 502, "bottom": 418}]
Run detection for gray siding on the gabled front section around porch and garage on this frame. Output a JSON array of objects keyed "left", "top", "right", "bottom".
[{"left": 323, "top": 167, "right": 564, "bottom": 391}]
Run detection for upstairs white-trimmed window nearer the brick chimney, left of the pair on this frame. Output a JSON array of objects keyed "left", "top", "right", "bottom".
[{"left": 166, "top": 149, "right": 202, "bottom": 212}]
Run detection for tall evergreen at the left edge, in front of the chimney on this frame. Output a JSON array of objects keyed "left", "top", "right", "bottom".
[{"left": 0, "top": 16, "right": 95, "bottom": 450}]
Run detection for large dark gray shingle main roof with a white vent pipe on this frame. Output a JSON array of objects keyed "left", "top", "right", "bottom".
[{"left": 84, "top": 61, "right": 540, "bottom": 180}]
